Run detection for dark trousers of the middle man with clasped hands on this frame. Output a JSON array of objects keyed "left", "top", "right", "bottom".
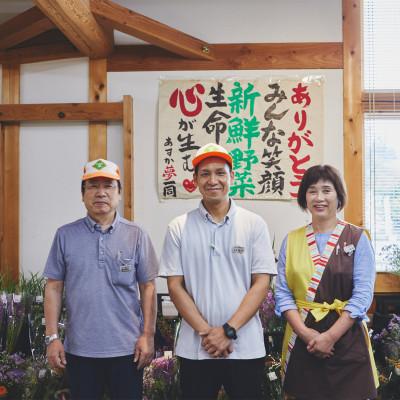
[{"left": 180, "top": 357, "right": 265, "bottom": 400}]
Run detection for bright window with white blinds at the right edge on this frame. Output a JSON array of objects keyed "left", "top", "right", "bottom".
[{"left": 363, "top": 0, "right": 400, "bottom": 270}]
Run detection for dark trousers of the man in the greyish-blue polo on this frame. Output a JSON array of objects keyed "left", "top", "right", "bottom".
[{"left": 66, "top": 354, "right": 143, "bottom": 400}]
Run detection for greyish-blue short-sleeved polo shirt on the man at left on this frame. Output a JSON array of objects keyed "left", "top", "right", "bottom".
[{"left": 43, "top": 213, "right": 158, "bottom": 358}]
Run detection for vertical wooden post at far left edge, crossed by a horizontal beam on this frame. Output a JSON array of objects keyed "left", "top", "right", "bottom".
[{"left": 0, "top": 64, "right": 20, "bottom": 282}]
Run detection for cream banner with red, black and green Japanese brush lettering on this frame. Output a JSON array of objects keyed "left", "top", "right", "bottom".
[{"left": 158, "top": 76, "right": 324, "bottom": 200}]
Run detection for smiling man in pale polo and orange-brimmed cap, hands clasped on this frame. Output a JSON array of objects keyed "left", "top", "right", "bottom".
[{"left": 160, "top": 143, "right": 276, "bottom": 400}]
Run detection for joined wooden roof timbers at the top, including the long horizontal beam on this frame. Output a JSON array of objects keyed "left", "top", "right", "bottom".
[{"left": 0, "top": 0, "right": 343, "bottom": 71}]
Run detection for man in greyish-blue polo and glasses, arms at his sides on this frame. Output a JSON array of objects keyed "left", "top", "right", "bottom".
[{"left": 44, "top": 159, "right": 158, "bottom": 400}]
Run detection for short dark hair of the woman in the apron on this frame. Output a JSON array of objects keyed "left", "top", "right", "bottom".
[{"left": 297, "top": 165, "right": 347, "bottom": 211}]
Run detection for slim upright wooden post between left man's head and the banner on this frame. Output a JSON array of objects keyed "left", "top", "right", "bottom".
[{"left": 123, "top": 96, "right": 134, "bottom": 220}]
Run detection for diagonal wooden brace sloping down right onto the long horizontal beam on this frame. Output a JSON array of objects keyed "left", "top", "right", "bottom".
[{"left": 90, "top": 0, "right": 214, "bottom": 60}]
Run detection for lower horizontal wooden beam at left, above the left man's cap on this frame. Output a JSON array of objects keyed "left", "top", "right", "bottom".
[{"left": 0, "top": 103, "right": 123, "bottom": 122}]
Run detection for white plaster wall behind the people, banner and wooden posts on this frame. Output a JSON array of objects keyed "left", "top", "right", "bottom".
[{"left": 0, "top": 0, "right": 343, "bottom": 289}]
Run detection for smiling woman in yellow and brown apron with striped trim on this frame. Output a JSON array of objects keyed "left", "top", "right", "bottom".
[{"left": 276, "top": 165, "right": 378, "bottom": 400}]
